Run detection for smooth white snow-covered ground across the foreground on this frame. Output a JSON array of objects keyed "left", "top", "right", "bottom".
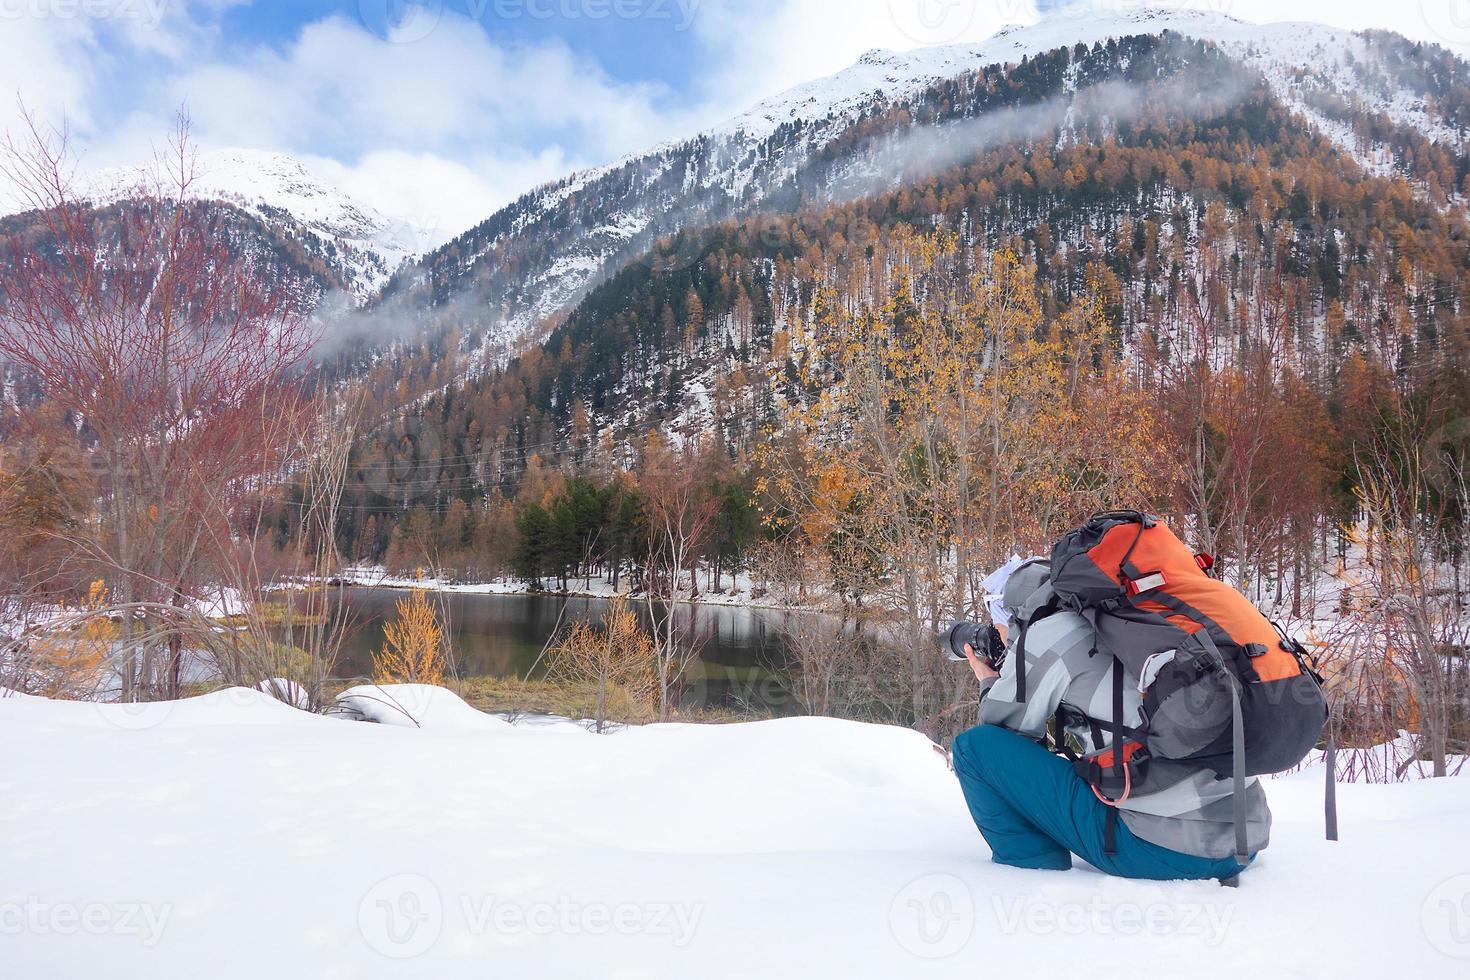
[{"left": 0, "top": 689, "right": 1470, "bottom": 980}]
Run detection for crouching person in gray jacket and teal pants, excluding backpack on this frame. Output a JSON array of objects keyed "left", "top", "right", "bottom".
[{"left": 950, "top": 560, "right": 1270, "bottom": 880}]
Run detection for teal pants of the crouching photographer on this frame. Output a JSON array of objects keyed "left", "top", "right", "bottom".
[{"left": 954, "top": 724, "right": 1241, "bottom": 880}]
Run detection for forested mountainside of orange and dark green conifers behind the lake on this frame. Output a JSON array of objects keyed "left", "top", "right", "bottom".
[{"left": 316, "top": 22, "right": 1470, "bottom": 590}]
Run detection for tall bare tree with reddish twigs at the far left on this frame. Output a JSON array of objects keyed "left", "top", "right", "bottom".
[{"left": 0, "top": 110, "right": 313, "bottom": 699}]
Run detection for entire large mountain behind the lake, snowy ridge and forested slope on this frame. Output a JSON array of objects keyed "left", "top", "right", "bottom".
[{"left": 324, "top": 5, "right": 1470, "bottom": 567}]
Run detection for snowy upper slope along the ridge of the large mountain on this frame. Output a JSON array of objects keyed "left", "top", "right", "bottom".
[{"left": 397, "top": 7, "right": 1464, "bottom": 359}]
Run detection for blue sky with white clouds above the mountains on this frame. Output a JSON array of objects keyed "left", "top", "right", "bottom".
[{"left": 0, "top": 0, "right": 1470, "bottom": 239}]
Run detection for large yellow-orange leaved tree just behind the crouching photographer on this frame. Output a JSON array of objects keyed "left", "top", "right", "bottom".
[{"left": 761, "top": 231, "right": 1157, "bottom": 734}]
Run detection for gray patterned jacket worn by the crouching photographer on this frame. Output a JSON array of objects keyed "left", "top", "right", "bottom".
[{"left": 980, "top": 563, "right": 1272, "bottom": 858}]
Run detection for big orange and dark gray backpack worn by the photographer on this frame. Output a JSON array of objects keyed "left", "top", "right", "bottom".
[{"left": 1020, "top": 511, "right": 1336, "bottom": 857}]
